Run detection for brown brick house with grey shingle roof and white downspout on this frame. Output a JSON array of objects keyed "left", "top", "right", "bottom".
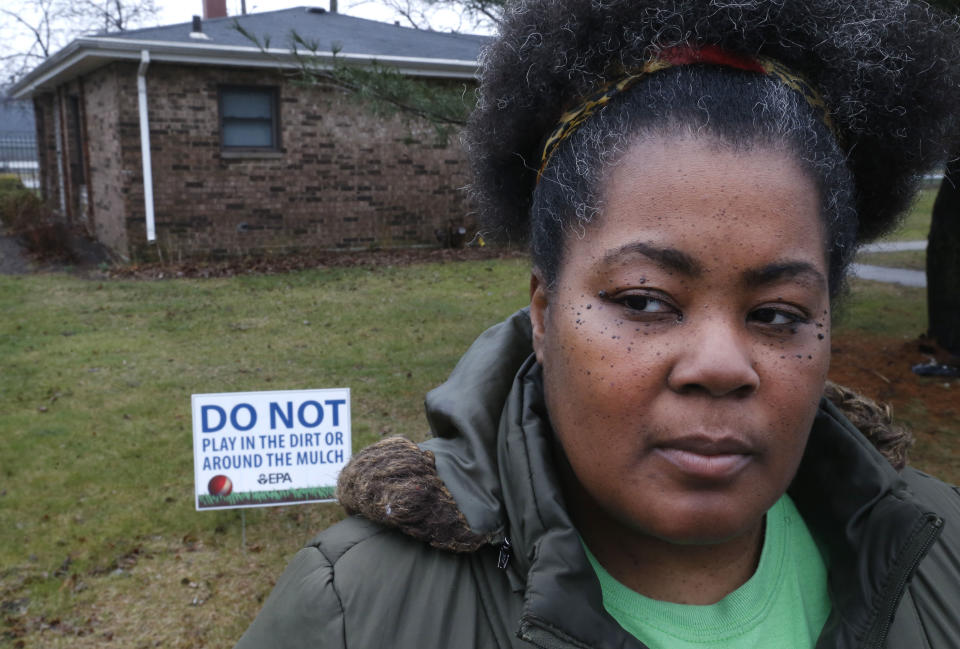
[{"left": 11, "top": 0, "right": 496, "bottom": 259}]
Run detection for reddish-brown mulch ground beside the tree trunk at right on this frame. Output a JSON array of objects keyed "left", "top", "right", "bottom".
[{"left": 830, "top": 332, "right": 960, "bottom": 484}]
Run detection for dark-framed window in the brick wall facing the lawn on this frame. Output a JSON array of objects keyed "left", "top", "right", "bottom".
[{"left": 220, "top": 86, "right": 280, "bottom": 151}]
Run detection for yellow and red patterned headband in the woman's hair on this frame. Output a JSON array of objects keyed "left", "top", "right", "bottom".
[{"left": 537, "top": 45, "right": 839, "bottom": 182}]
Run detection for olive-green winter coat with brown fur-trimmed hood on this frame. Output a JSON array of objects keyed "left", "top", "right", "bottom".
[{"left": 237, "top": 310, "right": 960, "bottom": 649}]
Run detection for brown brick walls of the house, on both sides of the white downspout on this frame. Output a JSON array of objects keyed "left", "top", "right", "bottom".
[{"left": 73, "top": 63, "right": 478, "bottom": 259}]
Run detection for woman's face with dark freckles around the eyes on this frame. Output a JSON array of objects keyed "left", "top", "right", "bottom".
[{"left": 531, "top": 138, "right": 830, "bottom": 543}]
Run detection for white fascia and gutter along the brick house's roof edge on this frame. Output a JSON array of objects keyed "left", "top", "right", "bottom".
[{"left": 10, "top": 37, "right": 479, "bottom": 99}]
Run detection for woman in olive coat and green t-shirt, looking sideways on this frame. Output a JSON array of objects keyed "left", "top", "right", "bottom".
[{"left": 234, "top": 0, "right": 960, "bottom": 649}]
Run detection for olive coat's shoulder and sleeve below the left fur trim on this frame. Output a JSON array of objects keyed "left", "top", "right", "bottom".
[{"left": 231, "top": 516, "right": 523, "bottom": 649}]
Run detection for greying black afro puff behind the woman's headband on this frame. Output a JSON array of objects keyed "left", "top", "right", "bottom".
[{"left": 464, "top": 0, "right": 960, "bottom": 247}]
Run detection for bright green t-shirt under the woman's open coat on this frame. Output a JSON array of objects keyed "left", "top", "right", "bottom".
[{"left": 584, "top": 494, "right": 830, "bottom": 649}]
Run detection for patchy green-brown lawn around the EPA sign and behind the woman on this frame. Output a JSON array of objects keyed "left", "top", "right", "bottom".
[{"left": 0, "top": 260, "right": 944, "bottom": 649}]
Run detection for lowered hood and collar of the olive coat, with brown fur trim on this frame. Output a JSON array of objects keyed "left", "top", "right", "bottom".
[{"left": 338, "top": 310, "right": 942, "bottom": 649}]
